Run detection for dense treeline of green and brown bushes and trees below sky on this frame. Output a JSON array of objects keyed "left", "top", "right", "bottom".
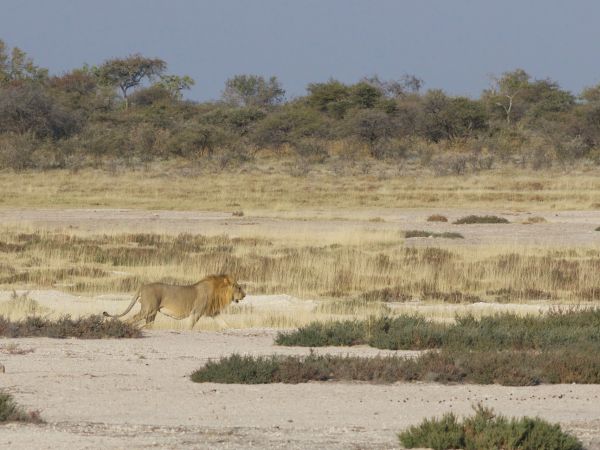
[{"left": 0, "top": 41, "right": 600, "bottom": 174}]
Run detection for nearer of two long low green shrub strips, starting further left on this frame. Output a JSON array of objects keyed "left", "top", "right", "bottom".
[{"left": 191, "top": 348, "right": 600, "bottom": 386}]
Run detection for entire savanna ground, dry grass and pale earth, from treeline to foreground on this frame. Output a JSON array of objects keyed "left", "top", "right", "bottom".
[{"left": 0, "top": 166, "right": 600, "bottom": 448}]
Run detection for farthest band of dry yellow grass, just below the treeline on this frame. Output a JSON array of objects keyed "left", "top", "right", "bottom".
[{"left": 0, "top": 165, "right": 600, "bottom": 214}]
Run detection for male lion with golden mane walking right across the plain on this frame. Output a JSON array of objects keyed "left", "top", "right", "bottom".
[{"left": 103, "top": 275, "right": 246, "bottom": 329}]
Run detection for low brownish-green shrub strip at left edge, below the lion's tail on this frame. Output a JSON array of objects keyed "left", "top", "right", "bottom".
[{"left": 0, "top": 315, "right": 142, "bottom": 339}]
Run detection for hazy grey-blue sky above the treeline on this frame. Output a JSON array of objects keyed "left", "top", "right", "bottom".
[{"left": 0, "top": 0, "right": 600, "bottom": 100}]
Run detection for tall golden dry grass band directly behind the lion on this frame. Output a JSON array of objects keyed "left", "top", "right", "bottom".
[{"left": 0, "top": 230, "right": 600, "bottom": 303}]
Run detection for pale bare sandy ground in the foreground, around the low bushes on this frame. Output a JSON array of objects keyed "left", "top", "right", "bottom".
[{"left": 0, "top": 330, "right": 600, "bottom": 449}]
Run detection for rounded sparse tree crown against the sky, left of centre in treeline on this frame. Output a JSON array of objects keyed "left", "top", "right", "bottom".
[{"left": 222, "top": 75, "right": 285, "bottom": 107}]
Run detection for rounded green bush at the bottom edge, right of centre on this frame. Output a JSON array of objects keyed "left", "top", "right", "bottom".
[{"left": 398, "top": 405, "right": 583, "bottom": 450}]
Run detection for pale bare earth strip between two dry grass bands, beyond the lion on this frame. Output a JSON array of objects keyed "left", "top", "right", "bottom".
[{"left": 0, "top": 208, "right": 600, "bottom": 246}]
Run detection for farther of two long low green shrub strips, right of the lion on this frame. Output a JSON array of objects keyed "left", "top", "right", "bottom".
[{"left": 276, "top": 309, "right": 600, "bottom": 351}]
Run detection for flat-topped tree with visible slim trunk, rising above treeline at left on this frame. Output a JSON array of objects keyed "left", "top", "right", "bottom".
[{"left": 95, "top": 54, "right": 167, "bottom": 109}]
